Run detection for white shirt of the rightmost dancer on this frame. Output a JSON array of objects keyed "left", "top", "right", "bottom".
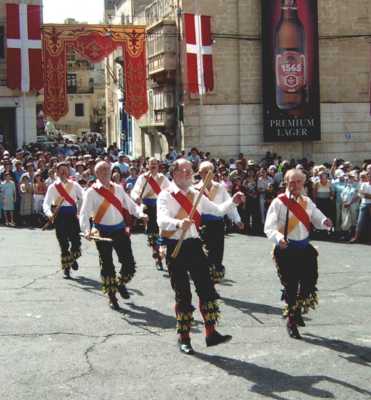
[{"left": 264, "top": 192, "right": 328, "bottom": 243}]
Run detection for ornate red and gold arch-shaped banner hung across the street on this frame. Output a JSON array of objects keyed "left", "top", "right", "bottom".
[{"left": 42, "top": 24, "right": 148, "bottom": 121}]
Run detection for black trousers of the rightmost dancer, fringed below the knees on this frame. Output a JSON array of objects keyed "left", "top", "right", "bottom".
[{"left": 274, "top": 244, "right": 318, "bottom": 314}]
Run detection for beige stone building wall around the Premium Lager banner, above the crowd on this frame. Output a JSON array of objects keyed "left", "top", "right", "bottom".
[{"left": 183, "top": 0, "right": 371, "bottom": 162}]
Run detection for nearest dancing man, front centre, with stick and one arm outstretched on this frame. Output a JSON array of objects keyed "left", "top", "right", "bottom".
[{"left": 157, "top": 159, "right": 244, "bottom": 354}]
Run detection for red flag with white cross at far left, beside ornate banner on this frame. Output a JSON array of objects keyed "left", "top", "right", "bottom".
[{"left": 6, "top": 4, "right": 43, "bottom": 93}]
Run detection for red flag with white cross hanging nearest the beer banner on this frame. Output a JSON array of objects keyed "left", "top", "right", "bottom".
[{"left": 184, "top": 14, "right": 214, "bottom": 95}]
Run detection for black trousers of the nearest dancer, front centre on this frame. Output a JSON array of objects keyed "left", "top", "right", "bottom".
[{"left": 167, "top": 239, "right": 219, "bottom": 333}]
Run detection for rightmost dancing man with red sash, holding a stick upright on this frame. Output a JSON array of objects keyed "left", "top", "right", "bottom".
[{"left": 264, "top": 169, "right": 332, "bottom": 339}]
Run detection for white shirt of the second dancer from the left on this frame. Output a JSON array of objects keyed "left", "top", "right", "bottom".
[{"left": 80, "top": 180, "right": 144, "bottom": 233}]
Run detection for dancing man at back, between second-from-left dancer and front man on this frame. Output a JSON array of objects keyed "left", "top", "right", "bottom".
[{"left": 130, "top": 158, "right": 170, "bottom": 271}]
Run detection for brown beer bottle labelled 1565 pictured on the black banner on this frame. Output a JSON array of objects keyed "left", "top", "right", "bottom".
[{"left": 275, "top": 0, "right": 306, "bottom": 111}]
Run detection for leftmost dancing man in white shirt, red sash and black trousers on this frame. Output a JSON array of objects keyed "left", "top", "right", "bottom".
[{"left": 43, "top": 162, "right": 83, "bottom": 279}]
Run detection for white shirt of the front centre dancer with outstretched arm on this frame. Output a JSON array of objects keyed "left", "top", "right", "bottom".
[{"left": 157, "top": 182, "right": 236, "bottom": 240}]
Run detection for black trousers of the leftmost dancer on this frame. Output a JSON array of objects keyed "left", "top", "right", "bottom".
[{"left": 54, "top": 213, "right": 81, "bottom": 269}]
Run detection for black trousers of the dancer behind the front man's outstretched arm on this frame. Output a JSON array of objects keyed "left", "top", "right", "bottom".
[{"left": 202, "top": 220, "right": 224, "bottom": 269}]
